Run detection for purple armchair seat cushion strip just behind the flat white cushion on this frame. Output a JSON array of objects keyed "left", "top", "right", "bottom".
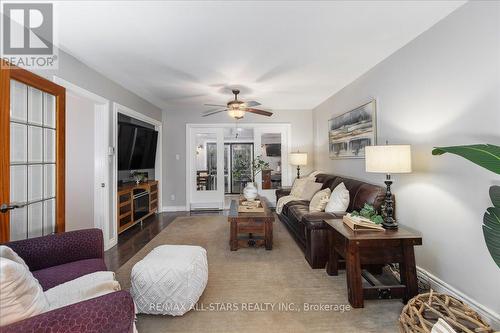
[{"left": 33, "top": 258, "right": 107, "bottom": 290}]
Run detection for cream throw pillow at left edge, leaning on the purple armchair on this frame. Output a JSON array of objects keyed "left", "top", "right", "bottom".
[{"left": 0, "top": 257, "right": 49, "bottom": 326}]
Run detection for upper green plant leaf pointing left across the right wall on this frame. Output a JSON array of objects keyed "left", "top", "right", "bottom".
[{"left": 432, "top": 144, "right": 500, "bottom": 175}]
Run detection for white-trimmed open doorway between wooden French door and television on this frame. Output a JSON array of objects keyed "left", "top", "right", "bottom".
[{"left": 53, "top": 76, "right": 111, "bottom": 249}]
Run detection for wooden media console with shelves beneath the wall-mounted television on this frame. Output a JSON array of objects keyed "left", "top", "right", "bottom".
[{"left": 116, "top": 180, "right": 158, "bottom": 234}]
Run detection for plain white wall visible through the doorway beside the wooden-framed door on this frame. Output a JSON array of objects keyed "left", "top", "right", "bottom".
[{"left": 66, "top": 94, "right": 95, "bottom": 231}]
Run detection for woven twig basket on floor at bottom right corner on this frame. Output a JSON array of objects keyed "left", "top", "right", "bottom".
[{"left": 399, "top": 290, "right": 493, "bottom": 333}]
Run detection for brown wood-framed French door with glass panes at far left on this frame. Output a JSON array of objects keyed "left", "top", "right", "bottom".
[{"left": 0, "top": 61, "right": 65, "bottom": 243}]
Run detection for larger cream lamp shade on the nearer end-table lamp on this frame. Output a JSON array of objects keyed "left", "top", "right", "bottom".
[{"left": 365, "top": 145, "right": 411, "bottom": 174}]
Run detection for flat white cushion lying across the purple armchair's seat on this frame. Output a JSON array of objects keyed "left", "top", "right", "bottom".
[{"left": 45, "top": 271, "right": 121, "bottom": 310}]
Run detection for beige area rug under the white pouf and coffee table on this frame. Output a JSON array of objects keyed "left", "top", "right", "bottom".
[{"left": 117, "top": 216, "right": 403, "bottom": 333}]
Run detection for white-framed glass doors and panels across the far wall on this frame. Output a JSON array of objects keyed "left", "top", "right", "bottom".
[{"left": 186, "top": 123, "right": 291, "bottom": 210}]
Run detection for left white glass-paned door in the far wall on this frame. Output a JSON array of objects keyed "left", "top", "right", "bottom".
[{"left": 187, "top": 128, "right": 224, "bottom": 210}]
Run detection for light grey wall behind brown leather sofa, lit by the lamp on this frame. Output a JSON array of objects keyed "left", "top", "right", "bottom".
[{"left": 313, "top": 1, "right": 500, "bottom": 323}]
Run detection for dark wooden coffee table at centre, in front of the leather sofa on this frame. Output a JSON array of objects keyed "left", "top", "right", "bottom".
[{"left": 227, "top": 198, "right": 274, "bottom": 251}]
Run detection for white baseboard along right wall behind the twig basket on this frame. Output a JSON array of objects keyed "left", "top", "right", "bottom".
[{"left": 417, "top": 266, "right": 500, "bottom": 329}]
